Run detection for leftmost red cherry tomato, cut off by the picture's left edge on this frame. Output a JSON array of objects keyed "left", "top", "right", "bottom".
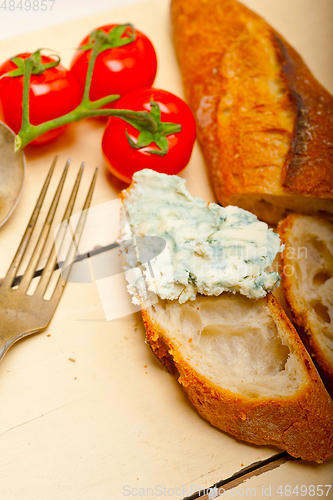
[{"left": 0, "top": 53, "right": 81, "bottom": 145}]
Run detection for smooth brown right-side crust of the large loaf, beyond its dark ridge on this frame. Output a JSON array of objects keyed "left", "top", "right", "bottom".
[{"left": 275, "top": 38, "right": 333, "bottom": 198}]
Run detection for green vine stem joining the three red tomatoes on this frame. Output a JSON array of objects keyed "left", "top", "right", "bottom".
[{"left": 4, "top": 25, "right": 181, "bottom": 155}]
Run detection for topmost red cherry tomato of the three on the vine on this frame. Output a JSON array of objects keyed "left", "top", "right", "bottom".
[{"left": 71, "top": 24, "right": 157, "bottom": 102}]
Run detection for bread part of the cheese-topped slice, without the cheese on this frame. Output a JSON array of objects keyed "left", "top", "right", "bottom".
[{"left": 142, "top": 293, "right": 333, "bottom": 462}]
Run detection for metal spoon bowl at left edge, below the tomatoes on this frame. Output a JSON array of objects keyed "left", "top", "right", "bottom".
[{"left": 0, "top": 122, "right": 25, "bottom": 227}]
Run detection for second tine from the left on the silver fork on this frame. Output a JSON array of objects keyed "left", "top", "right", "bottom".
[{"left": 19, "top": 160, "right": 70, "bottom": 293}]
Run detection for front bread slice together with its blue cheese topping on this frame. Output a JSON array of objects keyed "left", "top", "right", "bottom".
[{"left": 120, "top": 170, "right": 333, "bottom": 462}]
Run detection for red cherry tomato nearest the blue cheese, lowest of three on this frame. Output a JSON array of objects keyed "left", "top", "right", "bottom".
[{"left": 102, "top": 88, "right": 196, "bottom": 183}]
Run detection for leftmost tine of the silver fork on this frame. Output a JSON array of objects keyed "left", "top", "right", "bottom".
[{"left": 2, "top": 156, "right": 58, "bottom": 288}]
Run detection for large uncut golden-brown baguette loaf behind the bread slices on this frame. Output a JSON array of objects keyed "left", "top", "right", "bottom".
[{"left": 171, "top": 0, "right": 333, "bottom": 224}]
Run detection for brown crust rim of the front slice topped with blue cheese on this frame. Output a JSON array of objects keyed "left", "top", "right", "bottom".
[{"left": 142, "top": 294, "right": 333, "bottom": 462}]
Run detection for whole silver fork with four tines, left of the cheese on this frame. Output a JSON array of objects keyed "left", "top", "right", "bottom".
[{"left": 0, "top": 157, "right": 97, "bottom": 360}]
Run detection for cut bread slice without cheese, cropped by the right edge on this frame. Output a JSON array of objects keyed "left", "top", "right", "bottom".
[{"left": 278, "top": 214, "right": 333, "bottom": 397}]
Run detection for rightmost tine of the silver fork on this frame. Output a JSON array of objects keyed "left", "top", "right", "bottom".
[{"left": 50, "top": 168, "right": 98, "bottom": 309}]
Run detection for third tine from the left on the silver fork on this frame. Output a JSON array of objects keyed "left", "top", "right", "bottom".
[{"left": 35, "top": 163, "right": 84, "bottom": 296}]
